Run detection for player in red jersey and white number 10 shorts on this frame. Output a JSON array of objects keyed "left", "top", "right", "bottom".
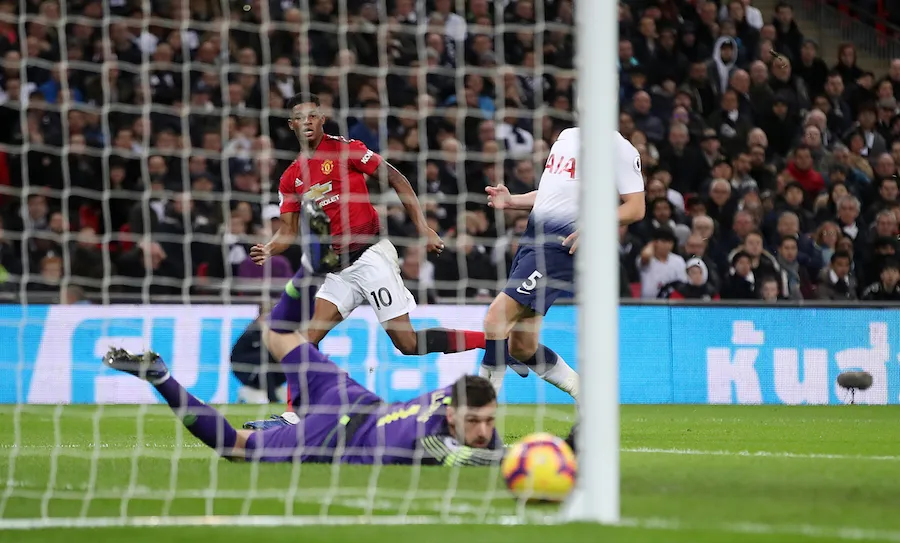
[{"left": 250, "top": 94, "right": 484, "bottom": 366}]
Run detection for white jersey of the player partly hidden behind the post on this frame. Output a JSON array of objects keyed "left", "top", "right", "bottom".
[{"left": 529, "top": 127, "right": 644, "bottom": 241}]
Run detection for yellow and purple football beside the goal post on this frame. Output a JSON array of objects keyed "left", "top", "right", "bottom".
[{"left": 500, "top": 433, "right": 578, "bottom": 502}]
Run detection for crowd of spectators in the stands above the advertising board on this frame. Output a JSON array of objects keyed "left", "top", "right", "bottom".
[{"left": 0, "top": 0, "right": 900, "bottom": 303}]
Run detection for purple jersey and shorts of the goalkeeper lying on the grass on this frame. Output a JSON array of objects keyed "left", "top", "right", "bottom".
[{"left": 246, "top": 345, "right": 503, "bottom": 465}]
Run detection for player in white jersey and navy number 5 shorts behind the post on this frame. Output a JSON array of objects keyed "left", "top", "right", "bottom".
[{"left": 480, "top": 127, "right": 645, "bottom": 400}]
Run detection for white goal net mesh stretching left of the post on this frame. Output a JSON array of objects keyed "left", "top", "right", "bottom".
[{"left": 0, "top": 0, "right": 592, "bottom": 527}]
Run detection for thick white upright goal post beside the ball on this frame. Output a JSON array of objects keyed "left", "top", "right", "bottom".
[{"left": 562, "top": 0, "right": 620, "bottom": 523}]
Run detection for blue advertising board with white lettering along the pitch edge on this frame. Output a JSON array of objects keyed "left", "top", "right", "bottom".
[{"left": 0, "top": 305, "right": 900, "bottom": 404}]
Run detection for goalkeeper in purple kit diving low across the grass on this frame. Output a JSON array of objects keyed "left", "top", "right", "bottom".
[{"left": 103, "top": 333, "right": 504, "bottom": 466}]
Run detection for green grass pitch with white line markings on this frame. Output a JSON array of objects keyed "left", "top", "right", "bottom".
[{"left": 0, "top": 405, "right": 900, "bottom": 543}]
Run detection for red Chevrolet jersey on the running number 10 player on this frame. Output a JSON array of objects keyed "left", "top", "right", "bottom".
[{"left": 278, "top": 134, "right": 382, "bottom": 253}]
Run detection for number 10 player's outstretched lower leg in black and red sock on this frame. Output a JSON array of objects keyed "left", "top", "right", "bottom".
[{"left": 382, "top": 313, "right": 484, "bottom": 355}]
